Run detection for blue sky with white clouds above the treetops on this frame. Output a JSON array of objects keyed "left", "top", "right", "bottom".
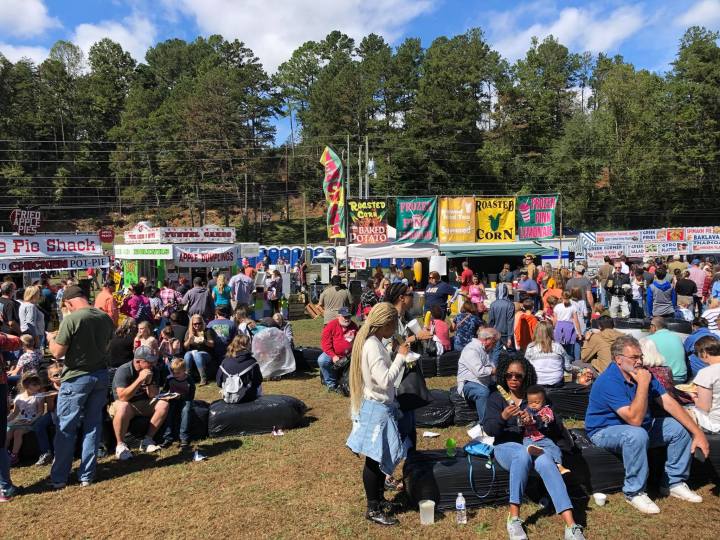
[{"left": 0, "top": 0, "right": 720, "bottom": 139}]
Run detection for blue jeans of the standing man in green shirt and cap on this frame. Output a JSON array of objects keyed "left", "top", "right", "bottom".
[{"left": 50, "top": 369, "right": 108, "bottom": 484}]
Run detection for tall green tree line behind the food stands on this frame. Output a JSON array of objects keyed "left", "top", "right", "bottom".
[{"left": 0, "top": 27, "right": 720, "bottom": 231}]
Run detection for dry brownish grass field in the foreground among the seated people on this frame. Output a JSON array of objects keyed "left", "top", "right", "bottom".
[{"left": 5, "top": 321, "right": 720, "bottom": 540}]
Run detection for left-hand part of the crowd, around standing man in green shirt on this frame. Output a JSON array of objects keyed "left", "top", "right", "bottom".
[{"left": 0, "top": 266, "right": 293, "bottom": 502}]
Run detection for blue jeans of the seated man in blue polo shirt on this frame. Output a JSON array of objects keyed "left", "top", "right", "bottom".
[{"left": 590, "top": 418, "right": 692, "bottom": 497}]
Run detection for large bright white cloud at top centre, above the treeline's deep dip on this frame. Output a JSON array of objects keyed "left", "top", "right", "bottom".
[{"left": 163, "top": 0, "right": 438, "bottom": 72}]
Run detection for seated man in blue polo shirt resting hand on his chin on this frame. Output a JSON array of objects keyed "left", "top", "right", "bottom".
[{"left": 585, "top": 336, "right": 710, "bottom": 514}]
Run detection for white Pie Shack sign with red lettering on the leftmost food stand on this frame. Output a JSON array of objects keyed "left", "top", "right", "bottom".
[{"left": 0, "top": 234, "right": 103, "bottom": 259}]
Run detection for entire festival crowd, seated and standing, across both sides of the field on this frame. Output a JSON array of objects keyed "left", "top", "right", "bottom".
[{"left": 0, "top": 255, "right": 720, "bottom": 540}]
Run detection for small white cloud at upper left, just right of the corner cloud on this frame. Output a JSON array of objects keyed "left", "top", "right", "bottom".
[{"left": 71, "top": 15, "right": 157, "bottom": 61}]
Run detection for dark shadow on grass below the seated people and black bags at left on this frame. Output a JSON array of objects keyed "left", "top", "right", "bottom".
[{"left": 23, "top": 438, "right": 243, "bottom": 494}]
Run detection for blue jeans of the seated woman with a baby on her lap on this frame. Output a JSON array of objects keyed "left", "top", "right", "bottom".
[{"left": 494, "top": 442, "right": 572, "bottom": 514}]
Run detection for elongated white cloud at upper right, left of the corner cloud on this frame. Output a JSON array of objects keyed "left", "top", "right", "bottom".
[{"left": 490, "top": 6, "right": 647, "bottom": 60}]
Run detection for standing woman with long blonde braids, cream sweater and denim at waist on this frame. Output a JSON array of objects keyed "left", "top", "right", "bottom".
[{"left": 346, "top": 302, "right": 408, "bottom": 525}]
